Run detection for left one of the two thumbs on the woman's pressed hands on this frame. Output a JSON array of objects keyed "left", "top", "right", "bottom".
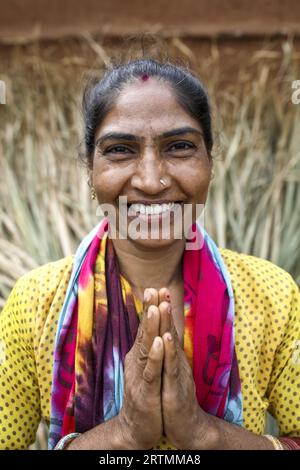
[{"left": 142, "top": 336, "right": 164, "bottom": 395}]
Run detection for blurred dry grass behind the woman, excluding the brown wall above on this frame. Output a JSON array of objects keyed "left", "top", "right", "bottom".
[{"left": 0, "top": 36, "right": 300, "bottom": 448}]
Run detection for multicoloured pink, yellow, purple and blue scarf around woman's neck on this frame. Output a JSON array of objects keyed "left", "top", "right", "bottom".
[{"left": 48, "top": 219, "right": 243, "bottom": 449}]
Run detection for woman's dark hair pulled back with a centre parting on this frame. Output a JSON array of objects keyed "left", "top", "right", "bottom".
[{"left": 83, "top": 58, "right": 213, "bottom": 165}]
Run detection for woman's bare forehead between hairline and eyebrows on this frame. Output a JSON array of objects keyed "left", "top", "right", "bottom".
[{"left": 97, "top": 77, "right": 201, "bottom": 136}]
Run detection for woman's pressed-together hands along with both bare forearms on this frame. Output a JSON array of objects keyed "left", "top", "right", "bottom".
[{"left": 67, "top": 288, "right": 273, "bottom": 450}]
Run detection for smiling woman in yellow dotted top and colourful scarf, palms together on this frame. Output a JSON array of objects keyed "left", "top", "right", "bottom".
[{"left": 0, "top": 59, "right": 300, "bottom": 450}]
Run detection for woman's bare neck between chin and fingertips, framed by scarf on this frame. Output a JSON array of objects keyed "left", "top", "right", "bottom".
[{"left": 113, "top": 239, "right": 185, "bottom": 299}]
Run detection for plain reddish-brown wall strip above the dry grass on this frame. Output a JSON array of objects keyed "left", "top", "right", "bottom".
[{"left": 0, "top": 0, "right": 300, "bottom": 42}]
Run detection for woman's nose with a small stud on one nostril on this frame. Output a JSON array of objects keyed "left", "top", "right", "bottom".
[{"left": 131, "top": 148, "right": 169, "bottom": 194}]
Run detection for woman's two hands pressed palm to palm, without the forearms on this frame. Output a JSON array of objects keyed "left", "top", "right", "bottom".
[{"left": 119, "top": 288, "right": 212, "bottom": 449}]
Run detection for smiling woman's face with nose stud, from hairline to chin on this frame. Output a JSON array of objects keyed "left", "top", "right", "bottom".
[{"left": 92, "top": 78, "right": 212, "bottom": 247}]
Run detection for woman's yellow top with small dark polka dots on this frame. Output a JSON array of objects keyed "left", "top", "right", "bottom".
[{"left": 0, "top": 250, "right": 300, "bottom": 450}]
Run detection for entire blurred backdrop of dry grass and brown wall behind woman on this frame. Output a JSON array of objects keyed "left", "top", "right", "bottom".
[{"left": 0, "top": 0, "right": 300, "bottom": 448}]
